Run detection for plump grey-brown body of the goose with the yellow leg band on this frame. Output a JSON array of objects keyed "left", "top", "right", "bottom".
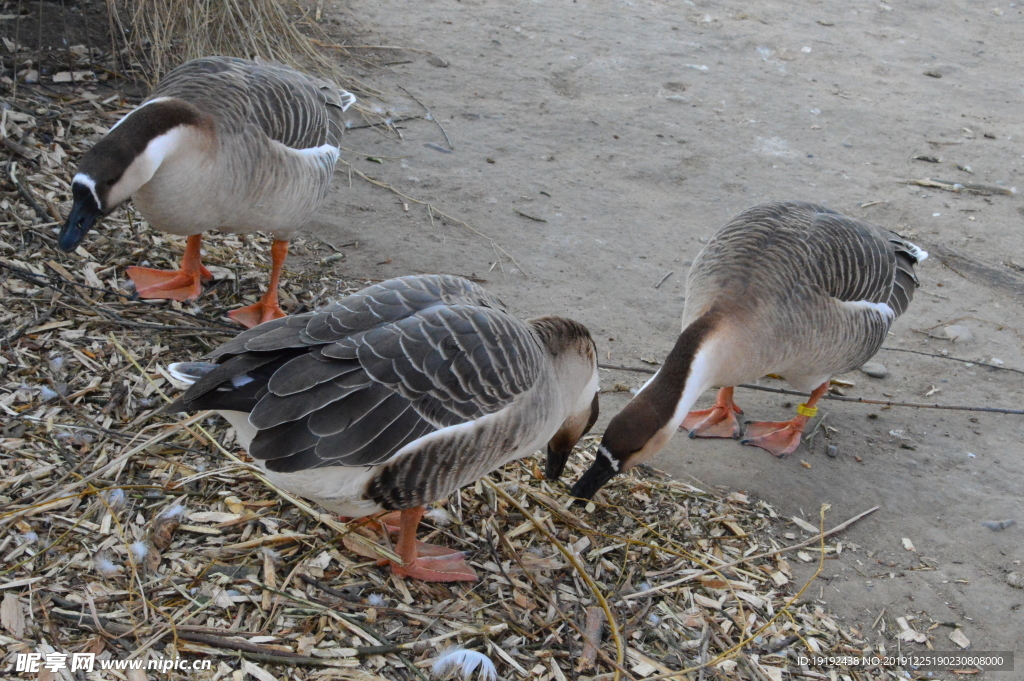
[{"left": 683, "top": 202, "right": 927, "bottom": 387}]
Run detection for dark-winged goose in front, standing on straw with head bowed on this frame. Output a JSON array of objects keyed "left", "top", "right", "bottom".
[{"left": 167, "top": 275, "right": 598, "bottom": 582}]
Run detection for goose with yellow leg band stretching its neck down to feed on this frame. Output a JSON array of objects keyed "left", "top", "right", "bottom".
[{"left": 572, "top": 202, "right": 928, "bottom": 499}]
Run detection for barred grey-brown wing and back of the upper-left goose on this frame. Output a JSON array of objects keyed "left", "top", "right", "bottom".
[{"left": 151, "top": 56, "right": 355, "bottom": 150}]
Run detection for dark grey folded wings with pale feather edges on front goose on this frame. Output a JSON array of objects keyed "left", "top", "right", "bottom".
[{"left": 175, "top": 276, "right": 543, "bottom": 472}]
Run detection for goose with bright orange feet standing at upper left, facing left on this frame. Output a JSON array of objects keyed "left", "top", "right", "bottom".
[{"left": 57, "top": 56, "right": 355, "bottom": 328}]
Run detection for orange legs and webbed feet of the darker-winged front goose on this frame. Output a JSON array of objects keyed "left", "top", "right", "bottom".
[{"left": 342, "top": 506, "right": 478, "bottom": 582}]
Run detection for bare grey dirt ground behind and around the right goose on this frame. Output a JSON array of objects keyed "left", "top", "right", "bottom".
[{"left": 313, "top": 0, "right": 1024, "bottom": 663}]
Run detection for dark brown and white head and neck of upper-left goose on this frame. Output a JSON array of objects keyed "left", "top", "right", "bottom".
[{"left": 57, "top": 97, "right": 206, "bottom": 252}]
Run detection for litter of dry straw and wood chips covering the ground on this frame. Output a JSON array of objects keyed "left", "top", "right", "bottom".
[{"left": 0, "top": 49, "right": 924, "bottom": 681}]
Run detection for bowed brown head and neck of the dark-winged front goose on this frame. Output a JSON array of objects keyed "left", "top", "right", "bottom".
[{"left": 529, "top": 316, "right": 600, "bottom": 480}]
